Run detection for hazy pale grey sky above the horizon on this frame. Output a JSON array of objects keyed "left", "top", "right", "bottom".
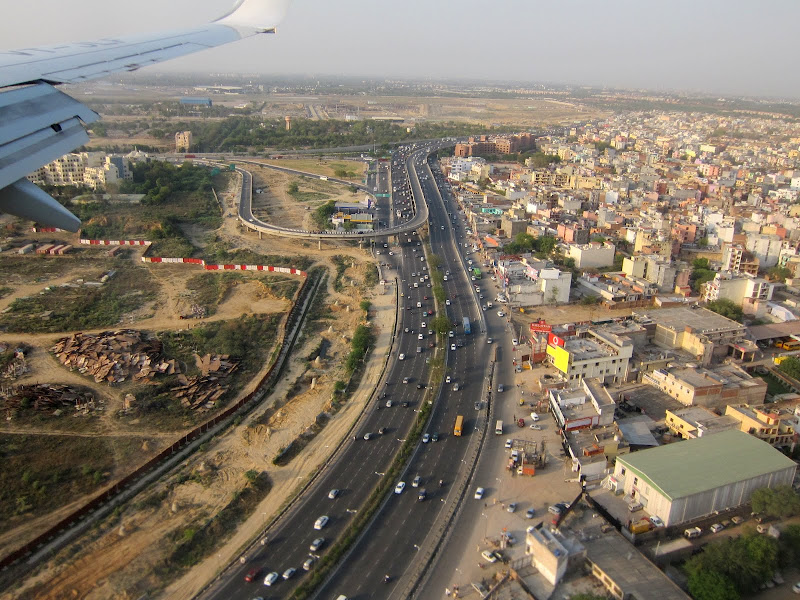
[{"left": 0, "top": 0, "right": 800, "bottom": 97}]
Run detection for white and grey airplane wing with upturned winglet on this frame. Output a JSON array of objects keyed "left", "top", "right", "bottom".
[{"left": 0, "top": 0, "right": 289, "bottom": 231}]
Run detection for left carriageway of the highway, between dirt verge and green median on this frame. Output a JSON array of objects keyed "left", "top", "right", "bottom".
[{"left": 204, "top": 143, "right": 456, "bottom": 599}]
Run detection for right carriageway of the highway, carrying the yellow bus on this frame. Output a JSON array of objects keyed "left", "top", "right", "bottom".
[{"left": 317, "top": 145, "right": 492, "bottom": 599}]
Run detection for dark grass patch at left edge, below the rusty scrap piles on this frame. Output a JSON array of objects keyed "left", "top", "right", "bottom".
[{"left": 0, "top": 434, "right": 144, "bottom": 531}]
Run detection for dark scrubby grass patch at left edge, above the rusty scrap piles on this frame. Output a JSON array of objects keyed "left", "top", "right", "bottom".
[{"left": 0, "top": 265, "right": 158, "bottom": 333}]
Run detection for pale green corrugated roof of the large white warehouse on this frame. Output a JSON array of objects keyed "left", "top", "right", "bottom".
[{"left": 617, "top": 430, "right": 796, "bottom": 500}]
